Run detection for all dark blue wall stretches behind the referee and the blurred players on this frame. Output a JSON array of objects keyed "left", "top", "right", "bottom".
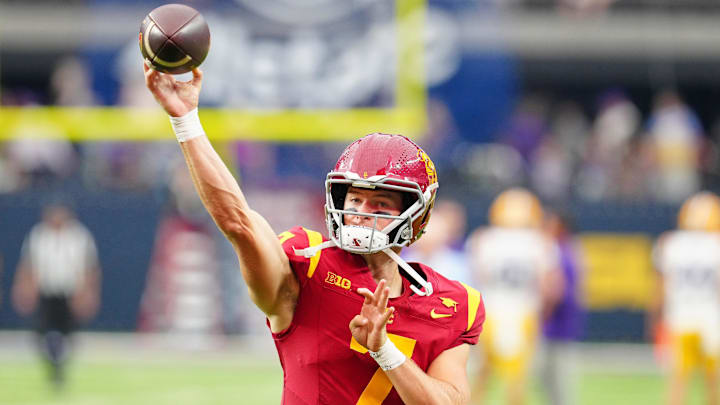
[{"left": 0, "top": 184, "right": 677, "bottom": 341}]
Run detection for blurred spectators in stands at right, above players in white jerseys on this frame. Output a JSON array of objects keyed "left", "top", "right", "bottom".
[{"left": 458, "top": 89, "right": 718, "bottom": 203}]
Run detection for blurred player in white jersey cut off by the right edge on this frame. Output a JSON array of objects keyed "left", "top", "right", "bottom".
[{"left": 653, "top": 192, "right": 720, "bottom": 405}]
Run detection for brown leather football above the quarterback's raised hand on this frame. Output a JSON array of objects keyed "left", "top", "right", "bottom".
[{"left": 138, "top": 4, "right": 210, "bottom": 74}]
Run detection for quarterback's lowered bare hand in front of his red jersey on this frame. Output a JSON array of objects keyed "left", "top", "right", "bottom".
[{"left": 350, "top": 280, "right": 395, "bottom": 352}]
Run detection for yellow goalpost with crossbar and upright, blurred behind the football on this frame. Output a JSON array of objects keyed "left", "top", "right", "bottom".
[{"left": 0, "top": 0, "right": 427, "bottom": 142}]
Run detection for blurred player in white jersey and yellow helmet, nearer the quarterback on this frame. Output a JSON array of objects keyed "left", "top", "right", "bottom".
[{"left": 468, "top": 188, "right": 562, "bottom": 405}]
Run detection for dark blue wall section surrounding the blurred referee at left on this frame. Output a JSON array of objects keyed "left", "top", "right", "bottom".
[{"left": 0, "top": 190, "right": 165, "bottom": 331}]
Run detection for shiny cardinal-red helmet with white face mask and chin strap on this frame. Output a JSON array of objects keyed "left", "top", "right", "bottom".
[{"left": 325, "top": 133, "right": 438, "bottom": 295}]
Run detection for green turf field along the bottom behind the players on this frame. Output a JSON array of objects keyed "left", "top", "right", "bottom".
[{"left": 0, "top": 361, "right": 702, "bottom": 405}]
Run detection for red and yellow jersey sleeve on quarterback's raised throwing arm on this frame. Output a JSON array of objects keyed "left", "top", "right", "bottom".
[{"left": 278, "top": 226, "right": 323, "bottom": 285}]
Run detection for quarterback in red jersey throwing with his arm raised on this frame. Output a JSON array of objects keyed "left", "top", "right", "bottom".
[{"left": 145, "top": 65, "right": 485, "bottom": 405}]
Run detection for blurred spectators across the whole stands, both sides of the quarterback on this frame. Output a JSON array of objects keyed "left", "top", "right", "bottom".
[{"left": 5, "top": 53, "right": 720, "bottom": 204}]
